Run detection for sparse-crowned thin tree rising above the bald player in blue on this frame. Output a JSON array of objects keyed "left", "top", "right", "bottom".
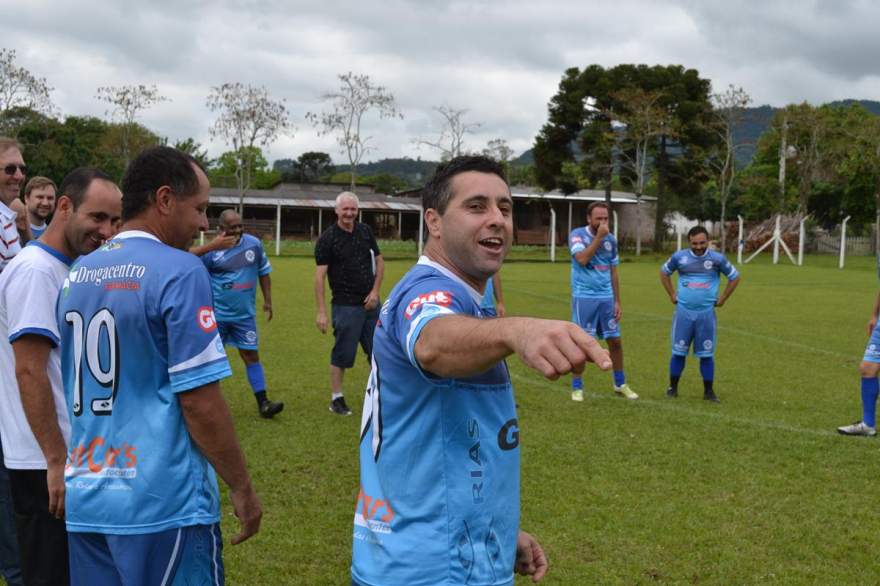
[{"left": 207, "top": 82, "right": 292, "bottom": 214}]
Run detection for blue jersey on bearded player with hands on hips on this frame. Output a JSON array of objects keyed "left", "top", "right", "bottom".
[{"left": 661, "top": 248, "right": 739, "bottom": 311}]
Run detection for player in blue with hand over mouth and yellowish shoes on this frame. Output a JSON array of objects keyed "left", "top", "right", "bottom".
[{"left": 568, "top": 201, "right": 639, "bottom": 401}]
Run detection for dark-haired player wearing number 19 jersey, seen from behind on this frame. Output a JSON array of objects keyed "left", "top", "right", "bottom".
[{"left": 57, "top": 147, "right": 262, "bottom": 586}]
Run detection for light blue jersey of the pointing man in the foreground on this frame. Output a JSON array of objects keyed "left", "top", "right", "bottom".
[{"left": 352, "top": 257, "right": 520, "bottom": 586}]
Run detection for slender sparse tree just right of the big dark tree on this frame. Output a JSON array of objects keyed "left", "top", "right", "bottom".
[{"left": 708, "top": 85, "right": 752, "bottom": 253}]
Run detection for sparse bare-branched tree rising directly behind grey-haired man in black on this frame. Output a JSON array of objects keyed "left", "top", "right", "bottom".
[{"left": 306, "top": 71, "right": 403, "bottom": 190}]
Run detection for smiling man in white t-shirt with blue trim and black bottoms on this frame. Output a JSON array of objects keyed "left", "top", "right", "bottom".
[{"left": 0, "top": 167, "right": 122, "bottom": 585}]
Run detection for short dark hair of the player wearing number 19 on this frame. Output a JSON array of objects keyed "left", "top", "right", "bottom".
[{"left": 122, "top": 146, "right": 204, "bottom": 221}]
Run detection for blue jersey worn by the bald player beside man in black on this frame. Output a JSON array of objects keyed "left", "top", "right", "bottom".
[{"left": 202, "top": 234, "right": 272, "bottom": 322}]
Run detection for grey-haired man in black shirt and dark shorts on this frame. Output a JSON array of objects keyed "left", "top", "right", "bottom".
[{"left": 315, "top": 191, "right": 385, "bottom": 415}]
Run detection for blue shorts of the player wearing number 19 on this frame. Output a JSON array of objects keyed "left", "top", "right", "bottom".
[{"left": 67, "top": 523, "right": 225, "bottom": 586}]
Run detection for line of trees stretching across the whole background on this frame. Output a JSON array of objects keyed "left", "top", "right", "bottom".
[{"left": 0, "top": 48, "right": 880, "bottom": 244}]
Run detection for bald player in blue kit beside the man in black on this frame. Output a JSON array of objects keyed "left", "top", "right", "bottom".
[{"left": 190, "top": 210, "right": 284, "bottom": 419}]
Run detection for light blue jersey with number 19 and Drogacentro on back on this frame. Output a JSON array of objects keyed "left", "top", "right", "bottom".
[{"left": 58, "top": 231, "right": 231, "bottom": 535}]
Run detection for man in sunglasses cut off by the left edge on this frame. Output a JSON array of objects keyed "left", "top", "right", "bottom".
[{"left": 0, "top": 137, "right": 27, "bottom": 585}]
